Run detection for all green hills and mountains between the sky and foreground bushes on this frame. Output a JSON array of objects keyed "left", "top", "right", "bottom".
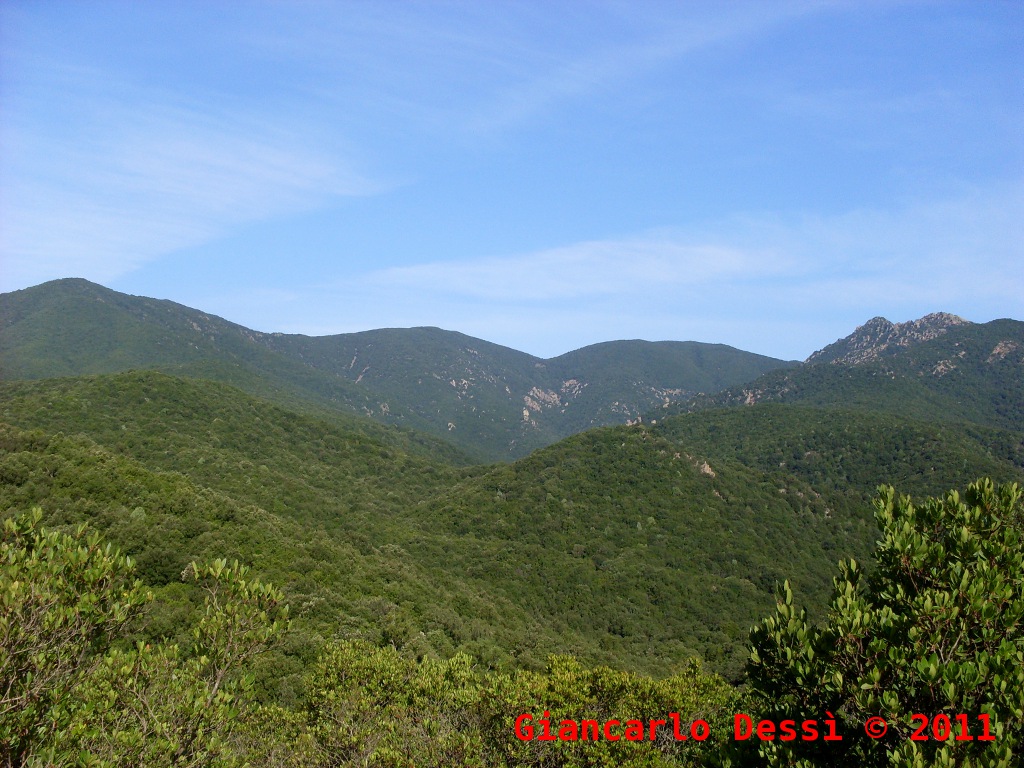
[{"left": 0, "top": 281, "right": 1024, "bottom": 765}]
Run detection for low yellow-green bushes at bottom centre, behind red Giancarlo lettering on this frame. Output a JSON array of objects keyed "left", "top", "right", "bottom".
[{"left": 242, "top": 642, "right": 736, "bottom": 768}]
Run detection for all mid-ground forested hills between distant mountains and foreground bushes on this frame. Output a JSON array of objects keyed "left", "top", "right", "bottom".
[{"left": 0, "top": 373, "right": 1024, "bottom": 678}]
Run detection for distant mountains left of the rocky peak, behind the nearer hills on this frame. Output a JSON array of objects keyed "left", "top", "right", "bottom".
[{"left": 0, "top": 280, "right": 791, "bottom": 461}]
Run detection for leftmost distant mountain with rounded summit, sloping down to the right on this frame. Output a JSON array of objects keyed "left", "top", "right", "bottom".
[{"left": 0, "top": 279, "right": 434, "bottom": 434}]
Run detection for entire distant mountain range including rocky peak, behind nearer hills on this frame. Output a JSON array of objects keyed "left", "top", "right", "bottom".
[{"left": 6, "top": 279, "right": 1024, "bottom": 463}]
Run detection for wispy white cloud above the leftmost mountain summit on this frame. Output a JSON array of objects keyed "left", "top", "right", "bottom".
[{"left": 0, "top": 77, "right": 383, "bottom": 285}]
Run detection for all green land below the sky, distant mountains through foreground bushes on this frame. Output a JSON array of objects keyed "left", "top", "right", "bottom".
[{"left": 0, "top": 281, "right": 1024, "bottom": 768}]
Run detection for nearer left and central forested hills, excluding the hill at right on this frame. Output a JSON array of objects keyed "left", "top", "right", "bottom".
[{"left": 0, "top": 372, "right": 847, "bottom": 675}]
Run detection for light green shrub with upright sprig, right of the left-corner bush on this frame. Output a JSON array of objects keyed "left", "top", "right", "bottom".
[{"left": 68, "top": 560, "right": 287, "bottom": 768}]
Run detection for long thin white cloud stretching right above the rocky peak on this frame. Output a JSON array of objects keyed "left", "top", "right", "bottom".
[{"left": 347, "top": 184, "right": 1024, "bottom": 325}]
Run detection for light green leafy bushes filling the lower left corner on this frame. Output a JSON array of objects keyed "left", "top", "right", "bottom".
[{"left": 0, "top": 511, "right": 287, "bottom": 768}]
